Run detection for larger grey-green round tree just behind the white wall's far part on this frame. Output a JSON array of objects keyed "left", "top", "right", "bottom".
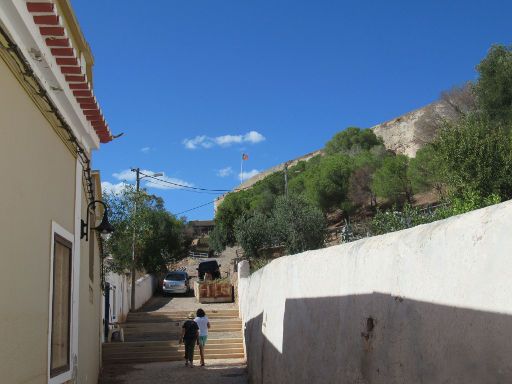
[{"left": 269, "top": 196, "right": 325, "bottom": 254}]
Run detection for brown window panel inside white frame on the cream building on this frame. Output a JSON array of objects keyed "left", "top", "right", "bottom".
[{"left": 50, "top": 234, "right": 73, "bottom": 377}]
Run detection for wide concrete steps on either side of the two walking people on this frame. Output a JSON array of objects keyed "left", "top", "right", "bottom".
[{"left": 103, "top": 309, "right": 244, "bottom": 364}]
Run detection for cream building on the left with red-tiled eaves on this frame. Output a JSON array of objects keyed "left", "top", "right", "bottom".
[{"left": 0, "top": 0, "right": 112, "bottom": 384}]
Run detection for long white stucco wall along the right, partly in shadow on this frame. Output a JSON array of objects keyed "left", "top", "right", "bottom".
[{"left": 239, "top": 201, "right": 512, "bottom": 384}]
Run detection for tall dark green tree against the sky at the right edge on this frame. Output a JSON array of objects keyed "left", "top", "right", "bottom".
[{"left": 475, "top": 45, "right": 512, "bottom": 121}]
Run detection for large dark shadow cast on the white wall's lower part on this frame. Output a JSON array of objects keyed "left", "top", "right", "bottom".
[{"left": 245, "top": 293, "right": 512, "bottom": 384}]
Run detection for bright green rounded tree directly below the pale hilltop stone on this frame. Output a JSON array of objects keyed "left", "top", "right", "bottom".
[{"left": 373, "top": 155, "right": 412, "bottom": 203}]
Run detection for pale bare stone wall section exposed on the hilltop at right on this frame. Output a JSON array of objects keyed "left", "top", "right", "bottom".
[{"left": 371, "top": 101, "right": 457, "bottom": 157}]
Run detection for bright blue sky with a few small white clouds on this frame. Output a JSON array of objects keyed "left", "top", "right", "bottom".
[{"left": 72, "top": 0, "right": 512, "bottom": 220}]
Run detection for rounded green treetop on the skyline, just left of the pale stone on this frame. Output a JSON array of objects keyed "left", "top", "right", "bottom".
[{"left": 325, "top": 127, "right": 383, "bottom": 155}]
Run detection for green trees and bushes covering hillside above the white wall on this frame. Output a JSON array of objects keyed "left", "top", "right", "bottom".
[{"left": 210, "top": 45, "right": 512, "bottom": 257}]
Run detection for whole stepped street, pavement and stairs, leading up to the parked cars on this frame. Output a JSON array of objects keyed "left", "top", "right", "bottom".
[{"left": 100, "top": 255, "right": 247, "bottom": 384}]
